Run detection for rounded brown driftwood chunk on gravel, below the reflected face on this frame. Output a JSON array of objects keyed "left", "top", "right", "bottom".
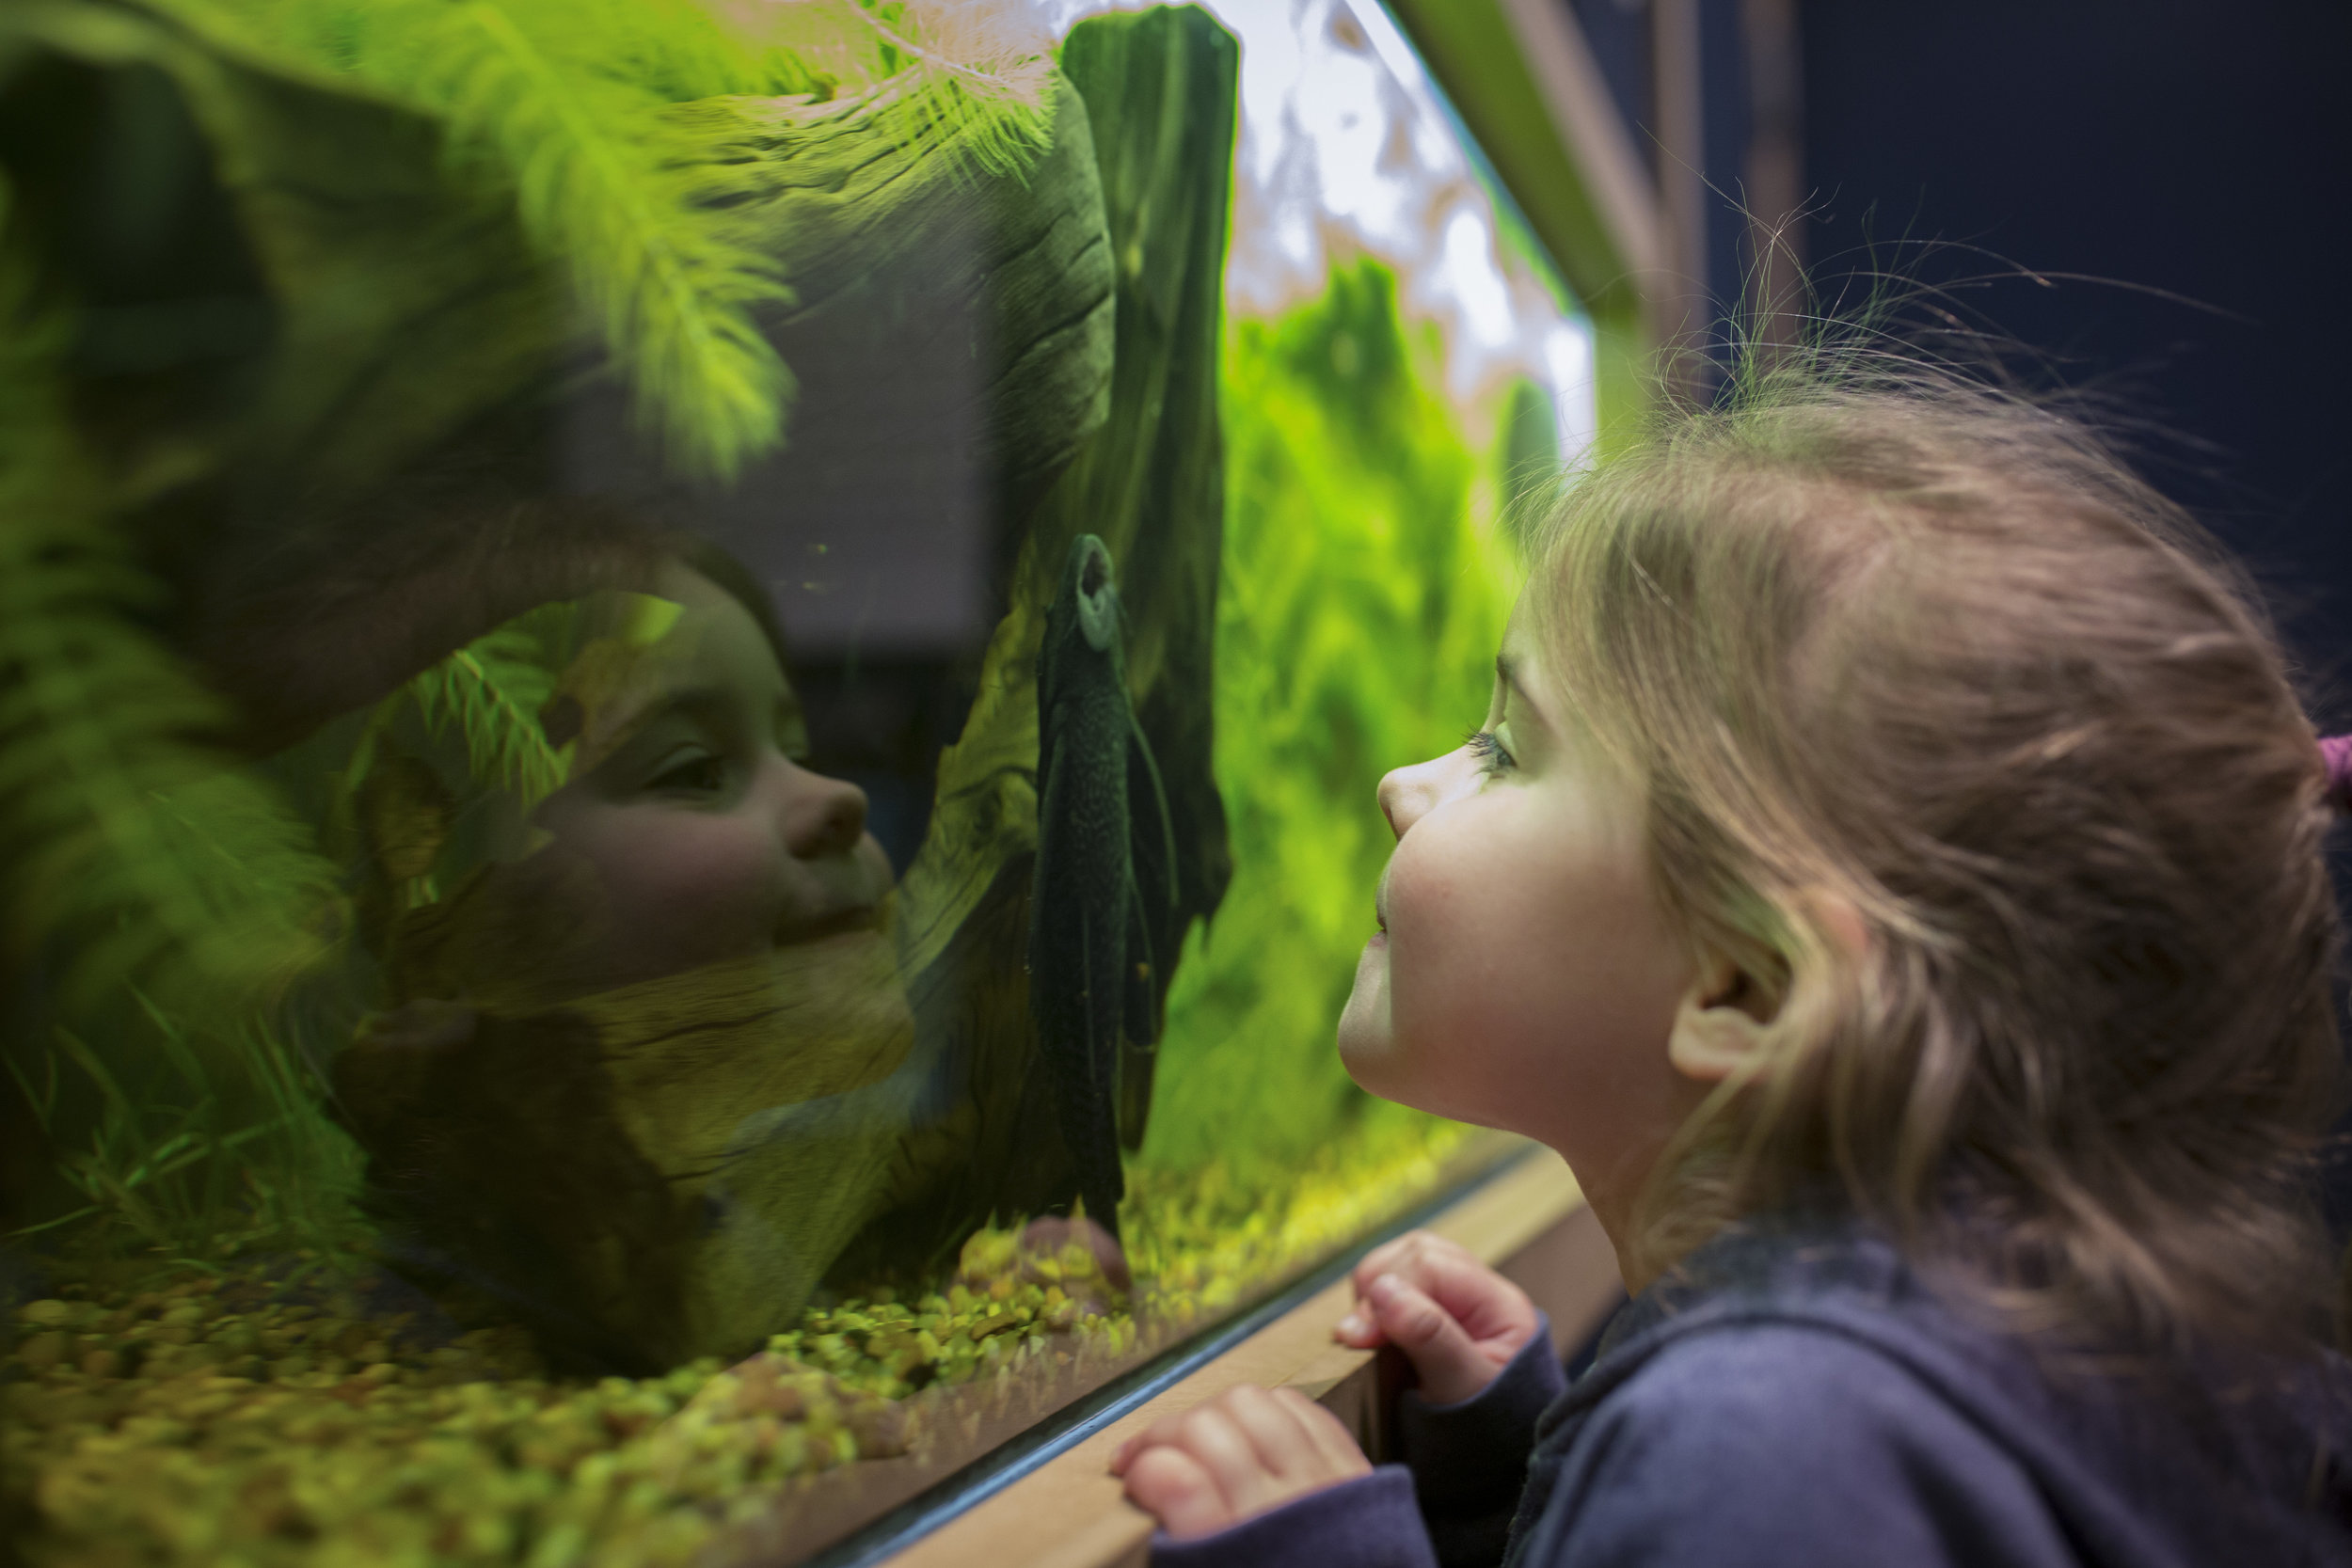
[{"left": 337, "top": 941, "right": 913, "bottom": 1373}]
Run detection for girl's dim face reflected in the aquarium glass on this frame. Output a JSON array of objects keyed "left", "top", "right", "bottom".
[{"left": 532, "top": 564, "right": 892, "bottom": 990}]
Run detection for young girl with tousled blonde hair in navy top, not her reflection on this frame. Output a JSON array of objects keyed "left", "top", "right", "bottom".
[{"left": 1115, "top": 369, "right": 2352, "bottom": 1568}]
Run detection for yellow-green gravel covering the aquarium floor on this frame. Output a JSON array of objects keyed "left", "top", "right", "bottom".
[{"left": 0, "top": 1129, "right": 1461, "bottom": 1568}]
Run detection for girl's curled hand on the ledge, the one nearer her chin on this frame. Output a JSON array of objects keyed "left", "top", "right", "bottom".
[{"left": 1331, "top": 1229, "right": 1538, "bottom": 1406}]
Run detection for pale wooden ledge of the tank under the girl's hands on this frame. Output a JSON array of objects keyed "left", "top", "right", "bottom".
[{"left": 889, "top": 1149, "right": 1618, "bottom": 1568}]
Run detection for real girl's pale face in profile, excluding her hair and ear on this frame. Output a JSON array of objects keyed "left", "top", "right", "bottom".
[{"left": 1339, "top": 607, "right": 1696, "bottom": 1192}]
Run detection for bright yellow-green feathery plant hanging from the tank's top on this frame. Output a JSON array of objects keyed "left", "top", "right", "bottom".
[{"left": 172, "top": 0, "right": 1052, "bottom": 480}]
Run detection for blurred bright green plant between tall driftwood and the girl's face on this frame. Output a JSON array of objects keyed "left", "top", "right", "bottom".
[{"left": 1146, "top": 261, "right": 1515, "bottom": 1176}]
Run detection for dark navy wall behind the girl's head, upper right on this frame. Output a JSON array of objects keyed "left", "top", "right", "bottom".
[{"left": 1566, "top": 0, "right": 2352, "bottom": 705}]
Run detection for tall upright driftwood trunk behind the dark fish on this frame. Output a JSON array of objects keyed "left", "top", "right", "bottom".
[{"left": 859, "top": 7, "right": 1240, "bottom": 1262}]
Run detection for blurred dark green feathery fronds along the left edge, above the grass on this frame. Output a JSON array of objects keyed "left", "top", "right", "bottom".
[{"left": 0, "top": 188, "right": 337, "bottom": 1006}]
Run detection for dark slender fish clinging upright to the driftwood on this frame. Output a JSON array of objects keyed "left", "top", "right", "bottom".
[{"left": 1030, "top": 533, "right": 1179, "bottom": 1237}]
